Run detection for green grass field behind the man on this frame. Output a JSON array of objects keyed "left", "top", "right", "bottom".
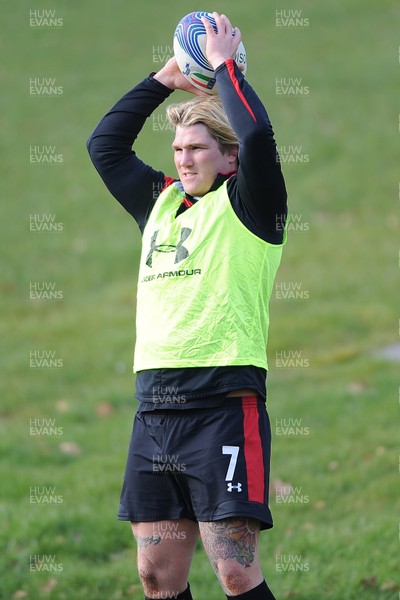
[{"left": 0, "top": 0, "right": 400, "bottom": 600}]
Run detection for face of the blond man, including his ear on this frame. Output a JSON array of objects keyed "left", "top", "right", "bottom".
[{"left": 172, "top": 123, "right": 236, "bottom": 196}]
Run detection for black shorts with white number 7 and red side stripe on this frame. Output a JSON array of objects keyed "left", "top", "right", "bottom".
[{"left": 118, "top": 396, "right": 273, "bottom": 529}]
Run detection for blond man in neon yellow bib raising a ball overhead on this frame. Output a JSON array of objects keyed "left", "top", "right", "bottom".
[{"left": 88, "top": 13, "right": 286, "bottom": 600}]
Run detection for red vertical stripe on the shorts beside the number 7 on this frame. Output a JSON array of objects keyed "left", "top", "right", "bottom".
[{"left": 242, "top": 396, "right": 265, "bottom": 503}]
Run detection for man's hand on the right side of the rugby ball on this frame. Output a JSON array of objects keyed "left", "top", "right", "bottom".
[{"left": 201, "top": 12, "right": 242, "bottom": 70}]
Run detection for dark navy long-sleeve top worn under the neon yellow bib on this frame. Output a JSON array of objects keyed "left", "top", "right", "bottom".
[{"left": 88, "top": 60, "right": 287, "bottom": 410}]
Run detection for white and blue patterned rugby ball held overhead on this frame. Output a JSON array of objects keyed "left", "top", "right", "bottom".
[{"left": 174, "top": 11, "right": 247, "bottom": 94}]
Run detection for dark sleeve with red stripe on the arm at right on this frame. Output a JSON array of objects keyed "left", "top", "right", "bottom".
[{"left": 215, "top": 60, "right": 287, "bottom": 243}]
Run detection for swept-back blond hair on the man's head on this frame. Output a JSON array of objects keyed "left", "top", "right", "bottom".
[{"left": 167, "top": 96, "right": 239, "bottom": 154}]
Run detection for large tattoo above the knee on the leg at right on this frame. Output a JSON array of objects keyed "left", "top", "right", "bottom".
[{"left": 201, "top": 519, "right": 258, "bottom": 567}]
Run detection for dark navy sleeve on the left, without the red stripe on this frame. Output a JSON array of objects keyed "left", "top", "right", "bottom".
[{"left": 87, "top": 75, "right": 173, "bottom": 231}]
